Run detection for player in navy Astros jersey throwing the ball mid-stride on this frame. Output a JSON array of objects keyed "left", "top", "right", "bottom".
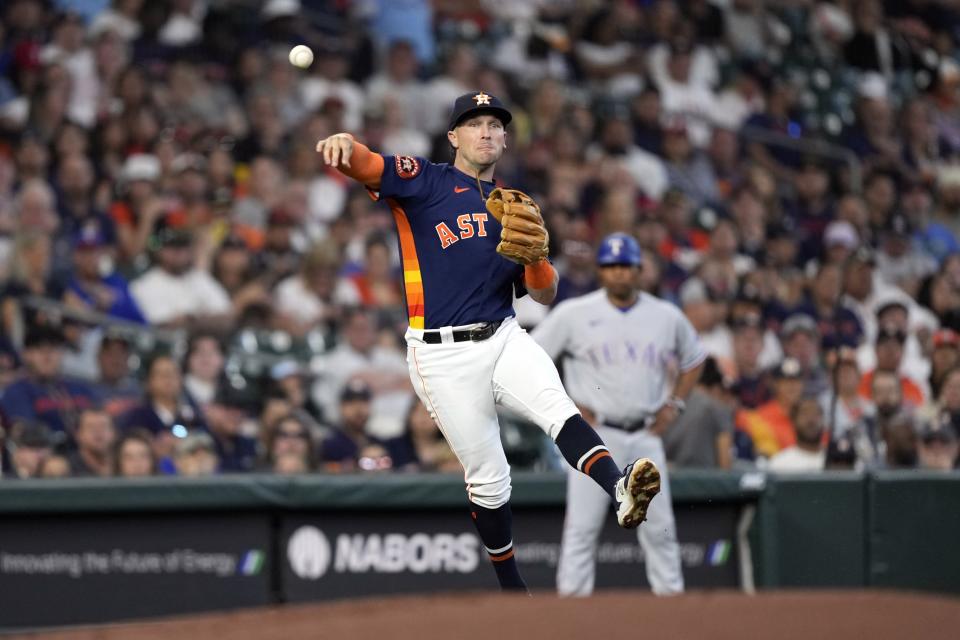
[{"left": 317, "top": 91, "right": 660, "bottom": 590}]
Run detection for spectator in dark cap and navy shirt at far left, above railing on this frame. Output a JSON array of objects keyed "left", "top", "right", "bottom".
[{"left": 0, "top": 325, "right": 99, "bottom": 441}]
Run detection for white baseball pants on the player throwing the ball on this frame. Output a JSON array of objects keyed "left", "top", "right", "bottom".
[{"left": 406, "top": 317, "right": 576, "bottom": 509}]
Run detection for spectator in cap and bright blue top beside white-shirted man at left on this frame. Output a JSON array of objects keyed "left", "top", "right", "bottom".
[{"left": 63, "top": 227, "right": 147, "bottom": 324}]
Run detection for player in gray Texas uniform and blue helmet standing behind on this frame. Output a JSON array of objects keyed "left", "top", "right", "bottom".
[{"left": 533, "top": 233, "right": 706, "bottom": 596}]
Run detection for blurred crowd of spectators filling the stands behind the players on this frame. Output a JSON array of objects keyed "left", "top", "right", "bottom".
[{"left": 0, "top": 0, "right": 960, "bottom": 477}]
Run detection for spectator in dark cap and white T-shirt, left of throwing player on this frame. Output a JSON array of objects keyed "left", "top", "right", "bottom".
[{"left": 130, "top": 221, "right": 233, "bottom": 330}]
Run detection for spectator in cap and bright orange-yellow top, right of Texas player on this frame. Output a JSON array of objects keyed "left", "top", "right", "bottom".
[{"left": 736, "top": 358, "right": 804, "bottom": 458}]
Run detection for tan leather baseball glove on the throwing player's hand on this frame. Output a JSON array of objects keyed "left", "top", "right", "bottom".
[{"left": 487, "top": 188, "right": 550, "bottom": 265}]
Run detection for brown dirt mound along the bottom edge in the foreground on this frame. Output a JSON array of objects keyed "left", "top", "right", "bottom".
[{"left": 15, "top": 591, "right": 960, "bottom": 640}]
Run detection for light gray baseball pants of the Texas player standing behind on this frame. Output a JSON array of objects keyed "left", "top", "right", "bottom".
[{"left": 557, "top": 426, "right": 683, "bottom": 596}]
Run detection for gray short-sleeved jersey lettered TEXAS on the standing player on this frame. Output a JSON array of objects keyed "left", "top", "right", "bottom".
[{"left": 532, "top": 289, "right": 707, "bottom": 423}]
